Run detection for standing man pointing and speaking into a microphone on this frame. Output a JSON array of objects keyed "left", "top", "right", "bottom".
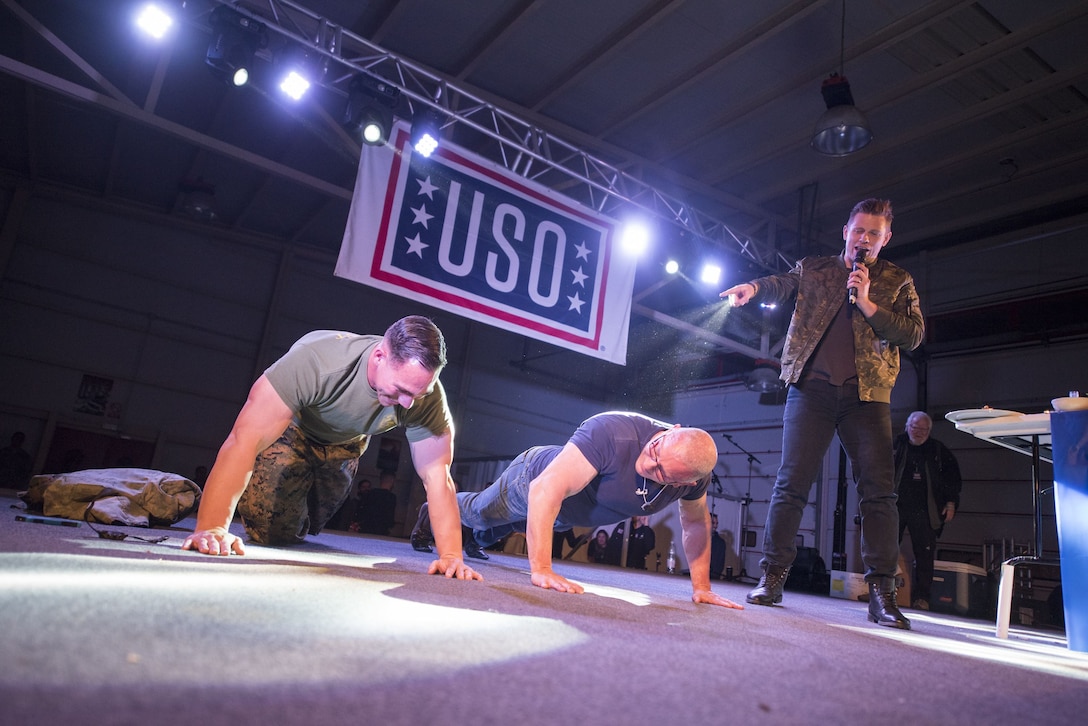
[{"left": 721, "top": 199, "right": 925, "bottom": 630}]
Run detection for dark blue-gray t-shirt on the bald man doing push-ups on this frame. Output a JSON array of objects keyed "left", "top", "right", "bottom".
[{"left": 548, "top": 411, "right": 710, "bottom": 527}]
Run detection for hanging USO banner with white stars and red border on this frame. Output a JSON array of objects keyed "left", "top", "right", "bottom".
[{"left": 335, "top": 124, "right": 635, "bottom": 365}]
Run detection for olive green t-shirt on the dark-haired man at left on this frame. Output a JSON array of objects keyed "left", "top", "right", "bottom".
[{"left": 264, "top": 330, "right": 454, "bottom": 444}]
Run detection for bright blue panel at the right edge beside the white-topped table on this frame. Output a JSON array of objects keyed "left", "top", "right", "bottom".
[{"left": 1050, "top": 410, "right": 1088, "bottom": 652}]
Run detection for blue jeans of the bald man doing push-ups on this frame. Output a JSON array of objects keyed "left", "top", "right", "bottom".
[{"left": 457, "top": 446, "right": 570, "bottom": 547}]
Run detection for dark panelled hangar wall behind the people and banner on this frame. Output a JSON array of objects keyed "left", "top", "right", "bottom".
[{"left": 0, "top": 183, "right": 1088, "bottom": 583}]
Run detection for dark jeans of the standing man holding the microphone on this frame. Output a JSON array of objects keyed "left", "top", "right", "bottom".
[{"left": 761, "top": 380, "right": 899, "bottom": 581}]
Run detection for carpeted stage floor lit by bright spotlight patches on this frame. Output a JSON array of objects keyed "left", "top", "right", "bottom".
[{"left": 0, "top": 497, "right": 1088, "bottom": 726}]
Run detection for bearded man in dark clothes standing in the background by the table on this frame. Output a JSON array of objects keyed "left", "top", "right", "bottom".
[{"left": 895, "top": 411, "right": 963, "bottom": 610}]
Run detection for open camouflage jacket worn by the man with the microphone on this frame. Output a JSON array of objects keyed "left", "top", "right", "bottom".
[{"left": 752, "top": 256, "right": 926, "bottom": 403}]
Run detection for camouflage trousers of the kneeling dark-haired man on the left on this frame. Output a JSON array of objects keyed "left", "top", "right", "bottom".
[{"left": 238, "top": 424, "right": 367, "bottom": 545}]
